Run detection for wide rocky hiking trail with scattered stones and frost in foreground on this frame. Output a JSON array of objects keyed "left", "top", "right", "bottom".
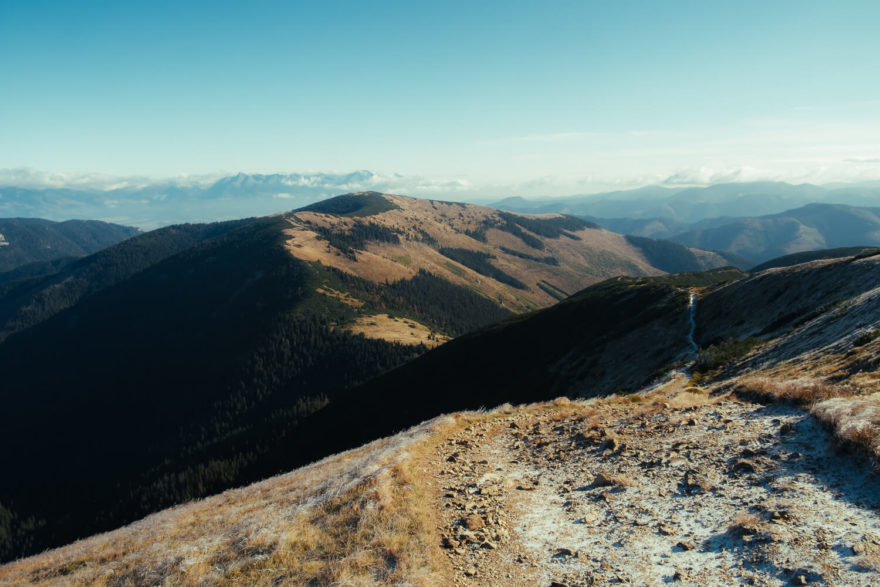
[{"left": 430, "top": 378, "right": 880, "bottom": 587}]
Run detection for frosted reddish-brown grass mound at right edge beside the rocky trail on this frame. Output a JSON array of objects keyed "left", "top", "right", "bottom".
[{"left": 811, "top": 394, "right": 880, "bottom": 463}]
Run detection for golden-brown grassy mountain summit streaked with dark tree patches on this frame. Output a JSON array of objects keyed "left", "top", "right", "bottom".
[{"left": 287, "top": 192, "right": 728, "bottom": 311}]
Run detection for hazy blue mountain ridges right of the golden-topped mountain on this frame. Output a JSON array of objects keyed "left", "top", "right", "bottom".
[{"left": 497, "top": 183, "right": 880, "bottom": 267}]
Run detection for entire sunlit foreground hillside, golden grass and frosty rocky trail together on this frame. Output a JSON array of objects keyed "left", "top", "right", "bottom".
[{"left": 0, "top": 378, "right": 880, "bottom": 585}]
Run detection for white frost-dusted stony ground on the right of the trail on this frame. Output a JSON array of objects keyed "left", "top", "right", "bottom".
[{"left": 506, "top": 401, "right": 880, "bottom": 585}]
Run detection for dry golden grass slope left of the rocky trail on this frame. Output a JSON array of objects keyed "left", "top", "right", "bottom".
[{"left": 0, "top": 417, "right": 458, "bottom": 586}]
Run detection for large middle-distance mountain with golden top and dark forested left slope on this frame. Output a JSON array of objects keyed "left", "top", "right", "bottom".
[{"left": 0, "top": 193, "right": 722, "bottom": 560}]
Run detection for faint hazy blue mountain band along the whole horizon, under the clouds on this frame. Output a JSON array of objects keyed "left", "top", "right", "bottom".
[{"left": 0, "top": 170, "right": 880, "bottom": 231}]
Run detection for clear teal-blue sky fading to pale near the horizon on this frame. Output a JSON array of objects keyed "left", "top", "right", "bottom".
[{"left": 0, "top": 0, "right": 880, "bottom": 196}]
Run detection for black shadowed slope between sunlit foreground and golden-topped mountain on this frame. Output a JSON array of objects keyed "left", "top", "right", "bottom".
[{"left": 272, "top": 269, "right": 745, "bottom": 470}]
